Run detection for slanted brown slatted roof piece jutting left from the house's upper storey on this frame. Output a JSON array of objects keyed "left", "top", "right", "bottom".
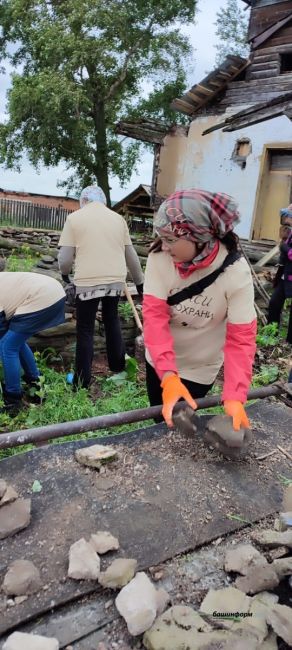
[{"left": 171, "top": 54, "right": 249, "bottom": 117}]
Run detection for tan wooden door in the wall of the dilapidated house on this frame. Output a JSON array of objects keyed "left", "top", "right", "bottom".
[{"left": 254, "top": 149, "right": 292, "bottom": 241}]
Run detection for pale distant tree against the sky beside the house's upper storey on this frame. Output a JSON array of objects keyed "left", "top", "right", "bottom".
[{"left": 215, "top": 0, "right": 249, "bottom": 65}]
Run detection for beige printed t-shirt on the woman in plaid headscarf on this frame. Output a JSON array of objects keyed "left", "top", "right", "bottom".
[{"left": 144, "top": 245, "right": 256, "bottom": 384}]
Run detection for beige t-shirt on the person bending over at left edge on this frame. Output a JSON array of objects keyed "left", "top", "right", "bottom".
[{"left": 0, "top": 271, "right": 65, "bottom": 320}]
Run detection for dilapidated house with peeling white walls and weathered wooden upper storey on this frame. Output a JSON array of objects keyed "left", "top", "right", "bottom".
[{"left": 118, "top": 0, "right": 292, "bottom": 241}]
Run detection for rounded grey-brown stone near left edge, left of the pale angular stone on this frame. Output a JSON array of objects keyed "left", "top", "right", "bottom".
[{"left": 2, "top": 560, "right": 41, "bottom": 596}]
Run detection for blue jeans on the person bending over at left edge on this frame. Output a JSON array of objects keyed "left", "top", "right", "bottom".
[{"left": 0, "top": 328, "right": 40, "bottom": 395}]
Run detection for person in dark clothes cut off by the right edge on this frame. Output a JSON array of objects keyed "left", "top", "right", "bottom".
[{"left": 268, "top": 203, "right": 292, "bottom": 345}]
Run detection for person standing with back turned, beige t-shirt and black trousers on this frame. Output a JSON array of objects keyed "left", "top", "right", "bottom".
[{"left": 58, "top": 185, "right": 144, "bottom": 388}]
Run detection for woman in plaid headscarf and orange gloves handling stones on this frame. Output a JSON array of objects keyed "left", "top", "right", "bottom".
[{"left": 143, "top": 189, "right": 256, "bottom": 430}]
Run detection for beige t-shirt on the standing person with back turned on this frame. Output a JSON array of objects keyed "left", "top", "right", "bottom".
[{"left": 59, "top": 201, "right": 132, "bottom": 287}]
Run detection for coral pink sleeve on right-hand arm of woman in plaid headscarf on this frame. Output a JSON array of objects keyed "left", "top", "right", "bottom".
[{"left": 222, "top": 319, "right": 257, "bottom": 403}]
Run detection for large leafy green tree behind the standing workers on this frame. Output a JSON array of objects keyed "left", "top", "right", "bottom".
[{"left": 0, "top": 0, "right": 196, "bottom": 202}]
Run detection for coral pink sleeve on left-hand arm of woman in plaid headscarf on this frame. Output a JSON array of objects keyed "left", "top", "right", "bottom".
[{"left": 143, "top": 294, "right": 178, "bottom": 379}]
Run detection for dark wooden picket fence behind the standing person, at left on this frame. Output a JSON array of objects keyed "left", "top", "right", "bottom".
[{"left": 0, "top": 199, "right": 72, "bottom": 230}]
